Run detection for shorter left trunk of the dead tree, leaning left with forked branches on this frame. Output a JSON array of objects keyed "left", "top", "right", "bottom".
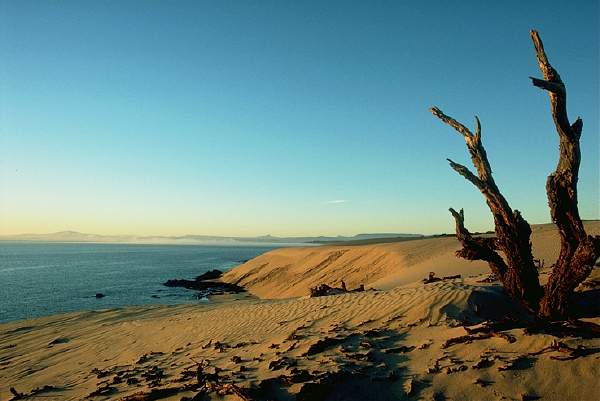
[{"left": 431, "top": 107, "right": 542, "bottom": 312}]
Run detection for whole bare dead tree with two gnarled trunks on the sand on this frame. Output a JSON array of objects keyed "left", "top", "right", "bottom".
[{"left": 431, "top": 31, "right": 600, "bottom": 318}]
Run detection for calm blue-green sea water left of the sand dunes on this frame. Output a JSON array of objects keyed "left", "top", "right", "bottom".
[{"left": 0, "top": 242, "right": 282, "bottom": 322}]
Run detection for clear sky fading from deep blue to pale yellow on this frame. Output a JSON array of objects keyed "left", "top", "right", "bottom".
[{"left": 0, "top": 0, "right": 600, "bottom": 236}]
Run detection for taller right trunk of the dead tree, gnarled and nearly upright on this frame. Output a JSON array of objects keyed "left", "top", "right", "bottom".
[{"left": 531, "top": 31, "right": 600, "bottom": 317}]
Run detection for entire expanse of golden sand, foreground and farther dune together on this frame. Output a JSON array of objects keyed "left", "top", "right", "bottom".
[{"left": 0, "top": 222, "right": 600, "bottom": 401}]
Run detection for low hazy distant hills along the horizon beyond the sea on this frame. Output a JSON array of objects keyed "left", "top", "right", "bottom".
[{"left": 0, "top": 231, "right": 422, "bottom": 245}]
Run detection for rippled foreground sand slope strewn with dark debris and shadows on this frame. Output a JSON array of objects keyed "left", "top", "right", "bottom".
[{"left": 0, "top": 280, "right": 600, "bottom": 400}]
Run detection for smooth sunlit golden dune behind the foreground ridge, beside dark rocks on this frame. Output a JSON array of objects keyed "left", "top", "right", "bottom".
[{"left": 224, "top": 221, "right": 600, "bottom": 298}]
